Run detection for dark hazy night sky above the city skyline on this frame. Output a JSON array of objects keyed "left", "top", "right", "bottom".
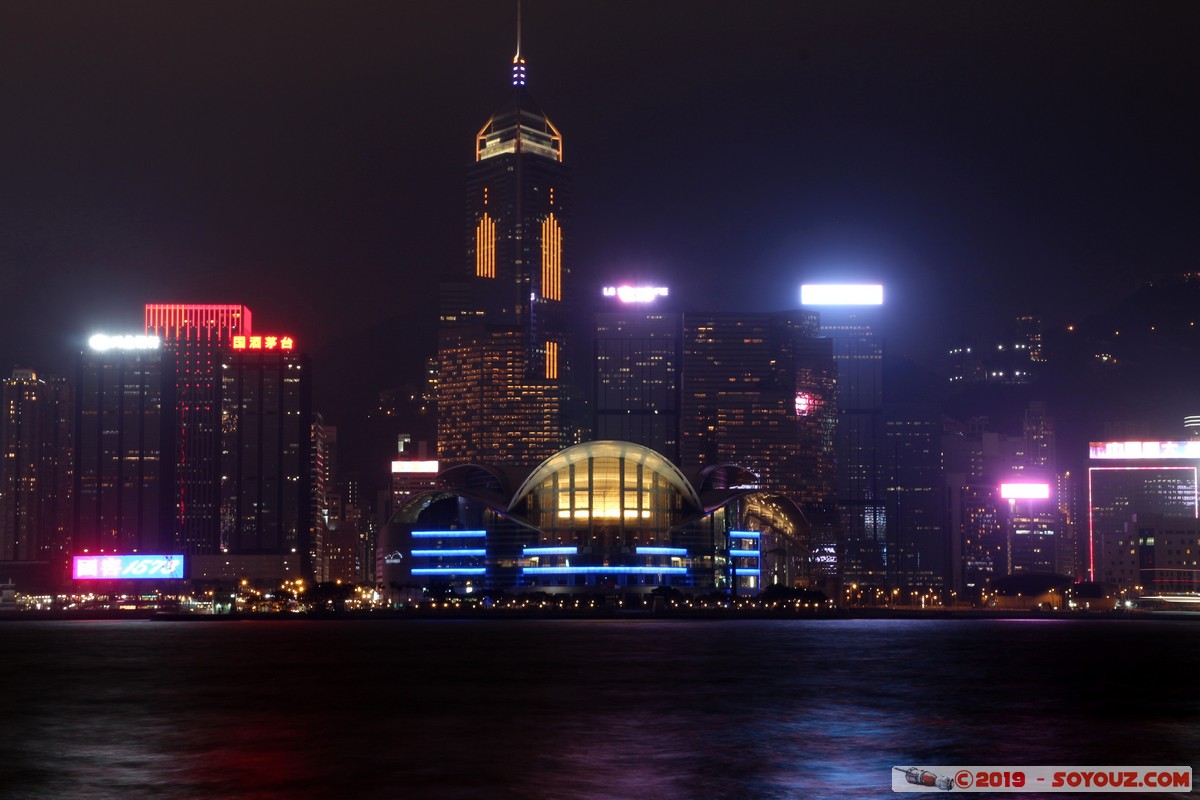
[{"left": 0, "top": 0, "right": 1200, "bottom": 410}]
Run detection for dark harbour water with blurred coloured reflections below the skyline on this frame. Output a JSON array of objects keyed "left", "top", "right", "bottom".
[{"left": 0, "top": 620, "right": 1200, "bottom": 800}]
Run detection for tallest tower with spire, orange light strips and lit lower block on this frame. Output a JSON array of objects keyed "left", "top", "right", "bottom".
[{"left": 438, "top": 11, "right": 578, "bottom": 465}]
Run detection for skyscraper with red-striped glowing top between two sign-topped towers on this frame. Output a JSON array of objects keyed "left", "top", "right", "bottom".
[{"left": 145, "top": 303, "right": 251, "bottom": 554}]
